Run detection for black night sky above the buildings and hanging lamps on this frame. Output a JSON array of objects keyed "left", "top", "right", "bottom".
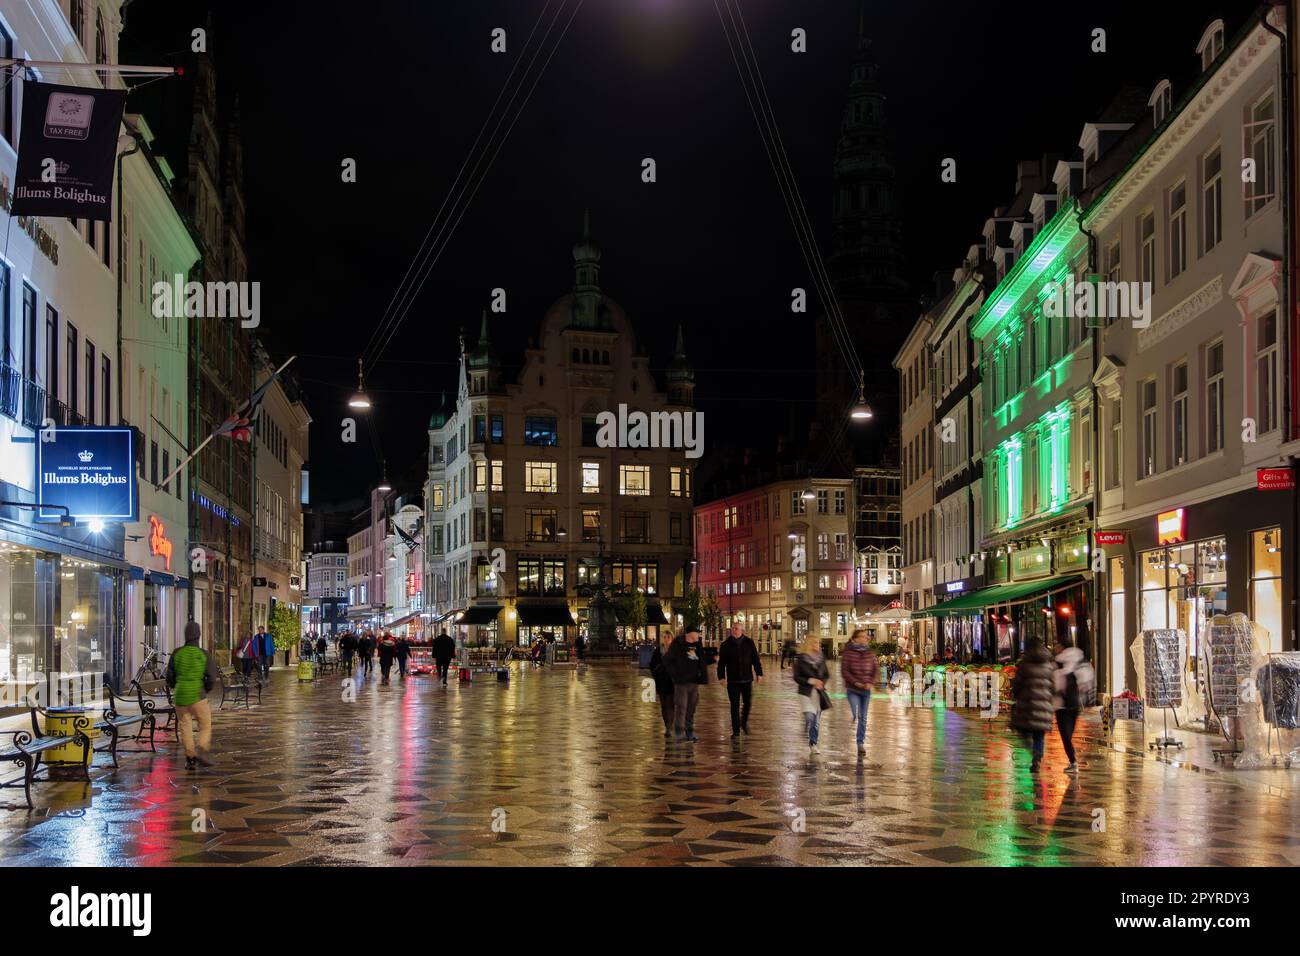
[{"left": 124, "top": 0, "right": 1255, "bottom": 520}]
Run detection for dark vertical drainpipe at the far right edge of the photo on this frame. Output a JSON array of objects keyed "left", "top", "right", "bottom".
[{"left": 1260, "top": 4, "right": 1300, "bottom": 648}]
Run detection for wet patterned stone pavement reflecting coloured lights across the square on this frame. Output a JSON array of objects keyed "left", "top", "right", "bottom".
[{"left": 0, "top": 663, "right": 1300, "bottom": 866}]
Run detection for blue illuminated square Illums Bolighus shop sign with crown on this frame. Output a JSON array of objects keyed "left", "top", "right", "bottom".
[{"left": 36, "top": 427, "right": 138, "bottom": 522}]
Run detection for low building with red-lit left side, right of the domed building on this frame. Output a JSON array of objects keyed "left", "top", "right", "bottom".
[{"left": 694, "top": 479, "right": 855, "bottom": 654}]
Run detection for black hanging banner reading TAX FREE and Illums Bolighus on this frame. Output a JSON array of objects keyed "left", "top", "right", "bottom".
[{"left": 13, "top": 82, "right": 126, "bottom": 222}]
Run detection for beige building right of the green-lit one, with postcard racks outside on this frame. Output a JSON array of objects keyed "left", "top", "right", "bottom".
[{"left": 1083, "top": 8, "right": 1300, "bottom": 692}]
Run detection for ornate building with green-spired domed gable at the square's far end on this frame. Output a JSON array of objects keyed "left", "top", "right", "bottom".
[{"left": 424, "top": 221, "right": 702, "bottom": 645}]
